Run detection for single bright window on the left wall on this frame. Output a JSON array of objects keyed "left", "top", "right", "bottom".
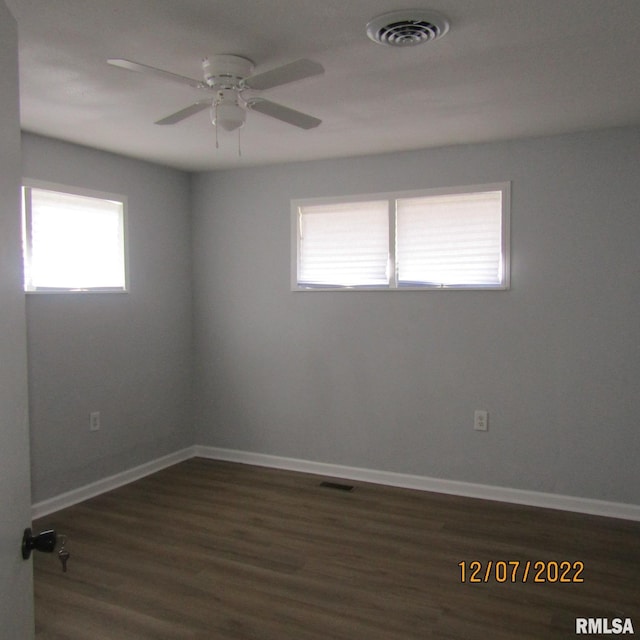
[{"left": 23, "top": 180, "right": 126, "bottom": 292}]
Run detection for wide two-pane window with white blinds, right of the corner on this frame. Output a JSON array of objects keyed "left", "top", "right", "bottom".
[{"left": 292, "top": 183, "right": 510, "bottom": 291}]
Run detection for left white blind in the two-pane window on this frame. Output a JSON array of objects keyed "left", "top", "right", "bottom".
[{"left": 298, "top": 200, "right": 389, "bottom": 287}]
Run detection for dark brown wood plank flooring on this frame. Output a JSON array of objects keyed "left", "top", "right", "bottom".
[{"left": 34, "top": 458, "right": 640, "bottom": 640}]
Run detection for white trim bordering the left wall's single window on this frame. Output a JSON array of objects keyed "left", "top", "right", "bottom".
[{"left": 22, "top": 178, "right": 130, "bottom": 296}]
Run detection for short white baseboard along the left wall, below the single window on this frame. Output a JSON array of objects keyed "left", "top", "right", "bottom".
[{"left": 31, "top": 447, "right": 195, "bottom": 520}]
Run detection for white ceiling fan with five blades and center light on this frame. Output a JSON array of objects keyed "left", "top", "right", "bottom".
[{"left": 107, "top": 54, "right": 324, "bottom": 131}]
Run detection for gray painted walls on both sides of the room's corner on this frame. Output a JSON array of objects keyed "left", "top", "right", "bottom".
[{"left": 23, "top": 128, "right": 640, "bottom": 504}]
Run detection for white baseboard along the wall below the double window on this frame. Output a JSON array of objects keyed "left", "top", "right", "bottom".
[{"left": 194, "top": 445, "right": 640, "bottom": 521}]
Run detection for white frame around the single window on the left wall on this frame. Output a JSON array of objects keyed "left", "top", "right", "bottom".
[{"left": 22, "top": 179, "right": 129, "bottom": 295}]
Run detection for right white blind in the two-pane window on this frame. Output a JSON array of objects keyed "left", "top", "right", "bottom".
[{"left": 396, "top": 191, "right": 502, "bottom": 287}]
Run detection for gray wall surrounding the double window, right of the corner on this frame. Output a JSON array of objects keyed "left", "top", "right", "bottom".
[{"left": 192, "top": 129, "right": 640, "bottom": 504}]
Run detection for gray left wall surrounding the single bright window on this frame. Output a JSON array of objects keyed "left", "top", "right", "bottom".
[{"left": 22, "top": 134, "right": 194, "bottom": 502}]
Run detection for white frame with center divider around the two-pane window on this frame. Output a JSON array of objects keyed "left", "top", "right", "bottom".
[{"left": 291, "top": 182, "right": 511, "bottom": 291}]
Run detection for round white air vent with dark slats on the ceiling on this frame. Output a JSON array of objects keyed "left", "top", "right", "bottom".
[{"left": 367, "top": 9, "right": 449, "bottom": 47}]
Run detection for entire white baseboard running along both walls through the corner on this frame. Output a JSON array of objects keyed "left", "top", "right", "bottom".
[{"left": 31, "top": 445, "right": 640, "bottom": 521}]
